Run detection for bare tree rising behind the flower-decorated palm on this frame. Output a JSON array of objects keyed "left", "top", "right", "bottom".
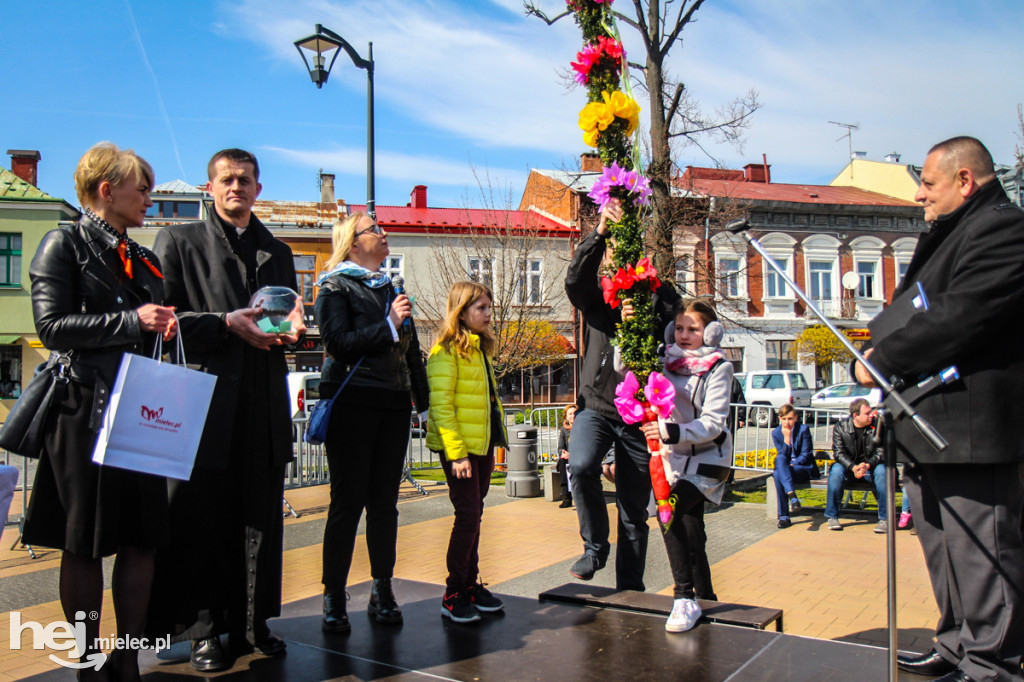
[{"left": 523, "top": 0, "right": 760, "bottom": 271}]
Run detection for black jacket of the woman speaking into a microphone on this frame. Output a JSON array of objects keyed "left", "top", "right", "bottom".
[{"left": 313, "top": 274, "right": 430, "bottom": 412}]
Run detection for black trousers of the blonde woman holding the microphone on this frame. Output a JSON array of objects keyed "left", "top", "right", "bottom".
[{"left": 323, "top": 404, "right": 409, "bottom": 592}]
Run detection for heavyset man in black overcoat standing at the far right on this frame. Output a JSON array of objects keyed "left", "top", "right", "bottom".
[{"left": 857, "top": 137, "right": 1024, "bottom": 682}]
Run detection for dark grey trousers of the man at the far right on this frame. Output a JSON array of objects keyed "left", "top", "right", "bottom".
[{"left": 903, "top": 464, "right": 1024, "bottom": 680}]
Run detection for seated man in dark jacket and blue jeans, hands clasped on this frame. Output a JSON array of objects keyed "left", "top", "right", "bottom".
[{"left": 825, "top": 398, "right": 887, "bottom": 532}]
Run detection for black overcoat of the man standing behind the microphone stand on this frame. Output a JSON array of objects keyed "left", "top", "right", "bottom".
[{"left": 870, "top": 180, "right": 1024, "bottom": 464}]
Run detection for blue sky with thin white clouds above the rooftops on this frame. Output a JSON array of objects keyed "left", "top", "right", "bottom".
[{"left": 0, "top": 0, "right": 1024, "bottom": 207}]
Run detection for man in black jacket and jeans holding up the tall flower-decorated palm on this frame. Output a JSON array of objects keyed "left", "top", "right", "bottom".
[{"left": 565, "top": 200, "right": 679, "bottom": 591}]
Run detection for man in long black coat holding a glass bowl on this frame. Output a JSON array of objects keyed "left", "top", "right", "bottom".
[{"left": 150, "top": 150, "right": 304, "bottom": 671}]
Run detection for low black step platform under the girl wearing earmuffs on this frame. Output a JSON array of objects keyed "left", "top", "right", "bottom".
[{"left": 538, "top": 583, "right": 782, "bottom": 632}]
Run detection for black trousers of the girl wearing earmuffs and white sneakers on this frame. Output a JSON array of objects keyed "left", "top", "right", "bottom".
[{"left": 662, "top": 480, "right": 717, "bottom": 600}]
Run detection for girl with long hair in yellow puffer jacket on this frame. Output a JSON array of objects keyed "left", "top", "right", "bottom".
[{"left": 427, "top": 282, "right": 508, "bottom": 623}]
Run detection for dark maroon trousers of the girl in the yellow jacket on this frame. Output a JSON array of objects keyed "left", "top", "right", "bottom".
[{"left": 441, "top": 454, "right": 495, "bottom": 594}]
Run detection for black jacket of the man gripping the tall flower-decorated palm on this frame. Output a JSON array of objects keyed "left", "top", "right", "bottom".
[{"left": 565, "top": 229, "right": 679, "bottom": 420}]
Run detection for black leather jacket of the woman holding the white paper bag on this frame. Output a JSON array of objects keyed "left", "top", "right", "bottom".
[{"left": 29, "top": 216, "right": 164, "bottom": 426}]
